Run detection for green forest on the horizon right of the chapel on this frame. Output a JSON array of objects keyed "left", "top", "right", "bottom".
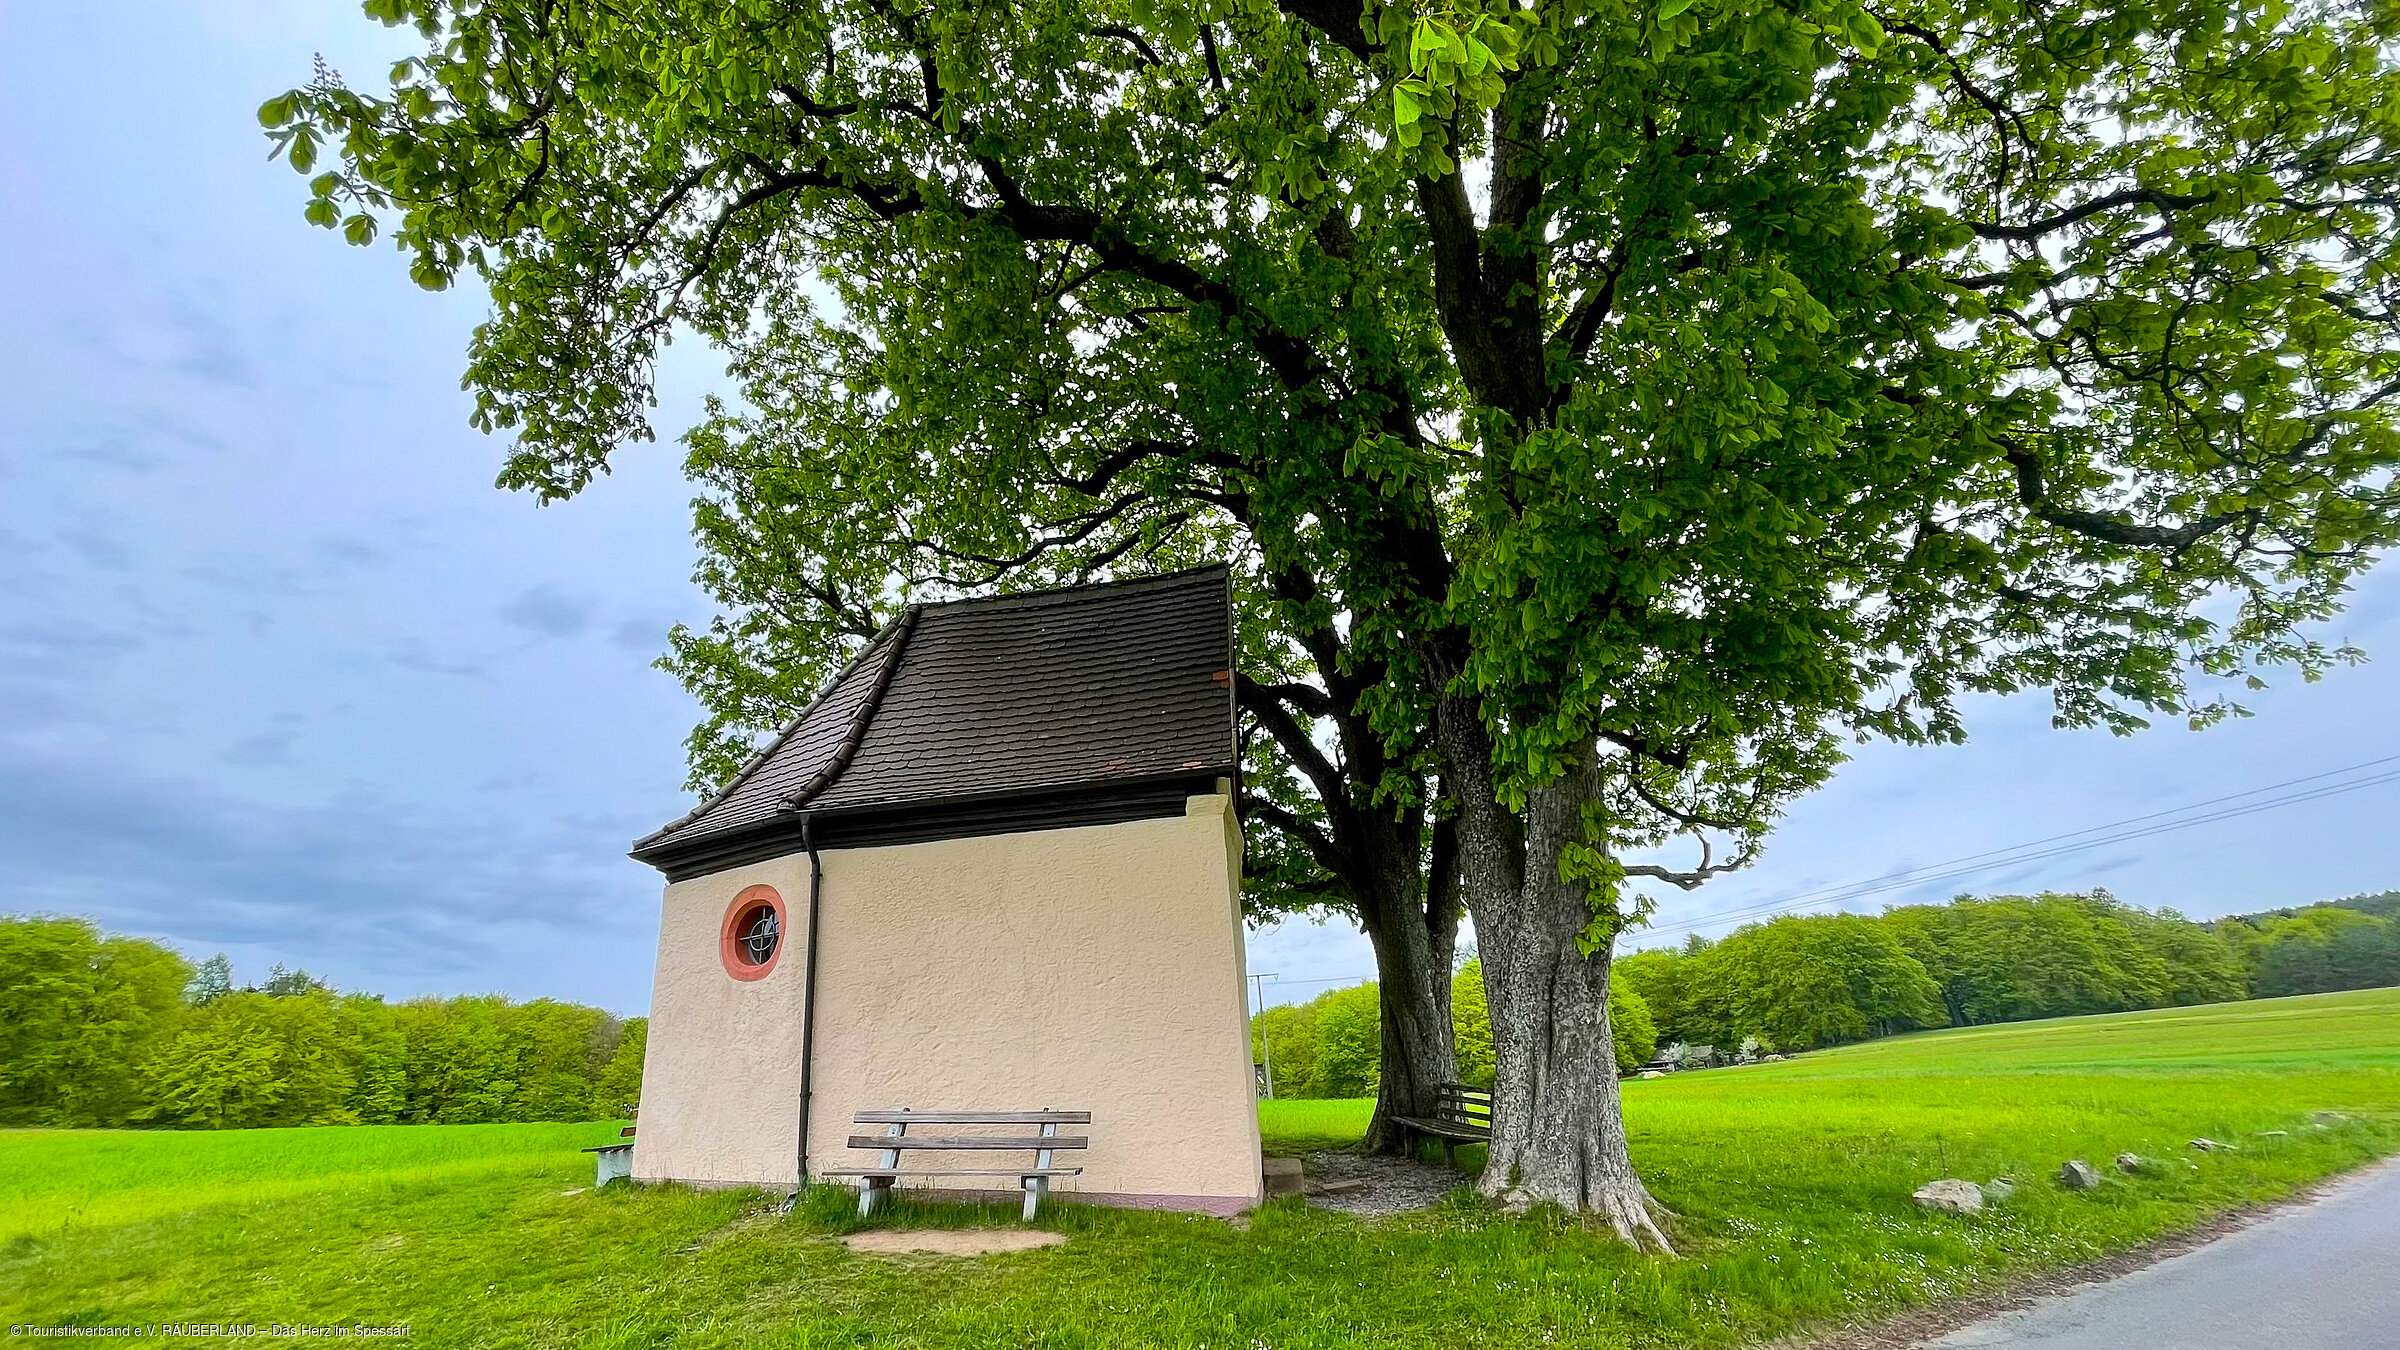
[{"left": 1250, "top": 891, "right": 2400, "bottom": 1098}]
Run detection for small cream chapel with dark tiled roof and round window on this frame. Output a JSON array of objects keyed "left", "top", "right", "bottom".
[{"left": 634, "top": 567, "right": 1260, "bottom": 1213}]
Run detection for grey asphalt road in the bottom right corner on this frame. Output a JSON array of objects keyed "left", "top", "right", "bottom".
[{"left": 1927, "top": 1143, "right": 2400, "bottom": 1350}]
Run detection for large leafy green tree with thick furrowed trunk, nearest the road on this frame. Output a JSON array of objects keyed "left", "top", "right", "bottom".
[{"left": 262, "top": 0, "right": 2400, "bottom": 1242}]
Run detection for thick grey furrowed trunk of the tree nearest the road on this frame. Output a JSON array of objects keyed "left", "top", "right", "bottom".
[{"left": 1442, "top": 706, "right": 1673, "bottom": 1252}]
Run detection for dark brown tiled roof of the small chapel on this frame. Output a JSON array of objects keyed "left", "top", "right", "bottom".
[{"left": 634, "top": 567, "right": 1234, "bottom": 855}]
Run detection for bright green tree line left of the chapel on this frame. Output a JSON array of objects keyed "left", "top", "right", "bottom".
[{"left": 0, "top": 915, "right": 648, "bottom": 1129}]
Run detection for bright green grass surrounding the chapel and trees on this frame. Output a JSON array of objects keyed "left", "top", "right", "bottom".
[{"left": 0, "top": 975, "right": 2400, "bottom": 1350}]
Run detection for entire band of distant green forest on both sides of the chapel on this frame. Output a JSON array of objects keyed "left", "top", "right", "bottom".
[{"left": 23, "top": 891, "right": 2400, "bottom": 1129}]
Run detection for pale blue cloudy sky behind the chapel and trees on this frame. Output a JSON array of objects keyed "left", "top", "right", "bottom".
[{"left": 0, "top": 0, "right": 2400, "bottom": 1011}]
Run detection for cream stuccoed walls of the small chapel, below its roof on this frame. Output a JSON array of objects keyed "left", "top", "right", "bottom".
[{"left": 634, "top": 795, "right": 1260, "bottom": 1213}]
